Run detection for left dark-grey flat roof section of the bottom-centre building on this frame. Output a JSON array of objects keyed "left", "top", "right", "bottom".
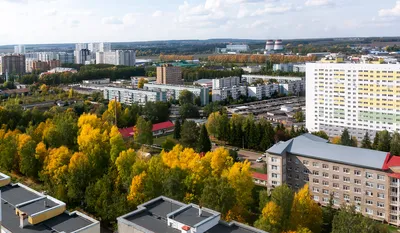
[{"left": 125, "top": 211, "right": 180, "bottom": 233}]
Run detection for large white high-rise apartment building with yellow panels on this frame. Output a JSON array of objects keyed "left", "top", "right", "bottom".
[{"left": 306, "top": 63, "right": 400, "bottom": 139}]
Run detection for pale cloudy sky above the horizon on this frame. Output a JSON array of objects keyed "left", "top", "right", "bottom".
[{"left": 0, "top": 0, "right": 400, "bottom": 45}]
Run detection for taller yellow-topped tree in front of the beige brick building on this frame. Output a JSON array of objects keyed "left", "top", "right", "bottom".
[{"left": 290, "top": 184, "right": 322, "bottom": 233}]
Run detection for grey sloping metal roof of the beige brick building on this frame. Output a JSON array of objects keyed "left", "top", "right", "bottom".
[{"left": 267, "top": 135, "right": 387, "bottom": 170}]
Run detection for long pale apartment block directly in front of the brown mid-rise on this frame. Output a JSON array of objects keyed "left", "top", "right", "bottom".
[{"left": 143, "top": 83, "right": 210, "bottom": 106}]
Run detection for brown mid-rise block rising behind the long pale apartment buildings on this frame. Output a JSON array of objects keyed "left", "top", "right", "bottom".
[{"left": 156, "top": 64, "right": 183, "bottom": 85}]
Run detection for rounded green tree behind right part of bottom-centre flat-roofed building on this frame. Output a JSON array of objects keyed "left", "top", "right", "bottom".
[{"left": 200, "top": 177, "right": 236, "bottom": 216}]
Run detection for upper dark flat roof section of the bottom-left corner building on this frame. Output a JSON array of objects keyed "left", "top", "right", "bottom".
[{"left": 0, "top": 185, "right": 40, "bottom": 206}]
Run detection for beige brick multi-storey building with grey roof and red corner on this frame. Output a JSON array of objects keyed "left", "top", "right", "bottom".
[{"left": 267, "top": 134, "right": 400, "bottom": 226}]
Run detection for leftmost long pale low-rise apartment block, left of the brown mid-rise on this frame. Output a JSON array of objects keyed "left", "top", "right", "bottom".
[{"left": 103, "top": 87, "right": 167, "bottom": 105}]
